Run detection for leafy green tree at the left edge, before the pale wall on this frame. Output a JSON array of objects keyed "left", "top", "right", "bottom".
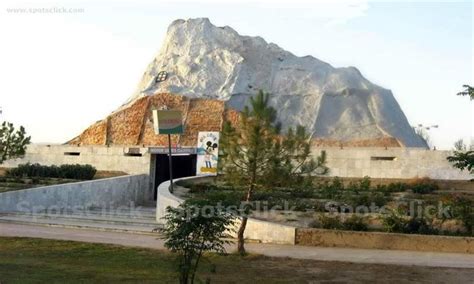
[{"left": 0, "top": 121, "right": 31, "bottom": 164}]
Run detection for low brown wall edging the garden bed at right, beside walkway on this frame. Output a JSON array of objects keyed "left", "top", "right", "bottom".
[{"left": 296, "top": 228, "right": 474, "bottom": 254}]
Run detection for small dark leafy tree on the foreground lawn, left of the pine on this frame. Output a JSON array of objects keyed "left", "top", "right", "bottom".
[{"left": 161, "top": 201, "right": 234, "bottom": 284}]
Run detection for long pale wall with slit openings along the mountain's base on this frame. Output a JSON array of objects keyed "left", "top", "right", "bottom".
[{"left": 2, "top": 144, "right": 474, "bottom": 180}]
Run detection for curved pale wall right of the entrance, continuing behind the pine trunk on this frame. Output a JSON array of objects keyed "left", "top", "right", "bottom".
[{"left": 156, "top": 177, "right": 296, "bottom": 245}]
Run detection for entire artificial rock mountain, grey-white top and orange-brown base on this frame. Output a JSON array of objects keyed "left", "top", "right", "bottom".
[{"left": 69, "top": 18, "right": 426, "bottom": 147}]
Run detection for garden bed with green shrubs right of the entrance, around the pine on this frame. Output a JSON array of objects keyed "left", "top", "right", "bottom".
[{"left": 174, "top": 175, "right": 474, "bottom": 236}]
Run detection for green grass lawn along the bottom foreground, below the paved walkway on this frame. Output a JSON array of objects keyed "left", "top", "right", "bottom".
[{"left": 0, "top": 235, "right": 474, "bottom": 284}]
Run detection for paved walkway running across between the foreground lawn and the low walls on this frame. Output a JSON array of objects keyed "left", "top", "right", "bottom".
[{"left": 0, "top": 223, "right": 474, "bottom": 269}]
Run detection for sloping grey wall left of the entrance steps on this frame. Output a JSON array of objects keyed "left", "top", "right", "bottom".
[{"left": 0, "top": 175, "right": 149, "bottom": 212}]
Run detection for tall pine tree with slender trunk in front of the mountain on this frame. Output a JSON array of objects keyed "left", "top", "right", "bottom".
[{"left": 219, "top": 91, "right": 328, "bottom": 254}]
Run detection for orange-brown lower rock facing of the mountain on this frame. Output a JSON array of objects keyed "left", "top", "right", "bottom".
[{"left": 68, "top": 94, "right": 401, "bottom": 147}]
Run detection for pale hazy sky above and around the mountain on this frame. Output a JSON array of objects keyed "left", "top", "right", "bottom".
[{"left": 0, "top": 0, "right": 474, "bottom": 149}]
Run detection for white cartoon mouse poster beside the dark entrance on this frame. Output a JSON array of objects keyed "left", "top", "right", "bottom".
[{"left": 196, "top": 132, "right": 219, "bottom": 175}]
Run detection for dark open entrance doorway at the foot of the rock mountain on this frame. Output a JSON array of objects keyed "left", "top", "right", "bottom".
[{"left": 154, "top": 154, "right": 197, "bottom": 200}]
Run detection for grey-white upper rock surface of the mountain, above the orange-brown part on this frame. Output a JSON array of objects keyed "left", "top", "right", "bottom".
[{"left": 128, "top": 18, "right": 426, "bottom": 147}]
